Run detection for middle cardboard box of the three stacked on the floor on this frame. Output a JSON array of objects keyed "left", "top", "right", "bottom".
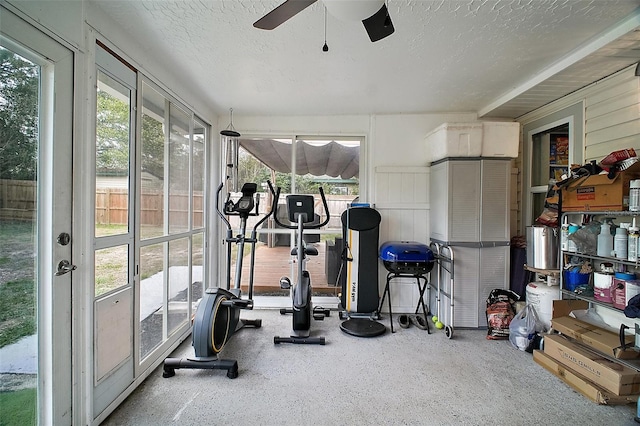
[{"left": 544, "top": 334, "right": 640, "bottom": 395}]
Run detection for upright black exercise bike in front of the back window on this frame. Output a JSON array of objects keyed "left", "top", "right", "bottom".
[{"left": 271, "top": 187, "right": 330, "bottom": 345}]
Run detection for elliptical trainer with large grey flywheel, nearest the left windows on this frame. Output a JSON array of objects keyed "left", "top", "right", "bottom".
[{"left": 162, "top": 182, "right": 275, "bottom": 379}]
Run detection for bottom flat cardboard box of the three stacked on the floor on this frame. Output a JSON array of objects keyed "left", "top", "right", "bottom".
[{"left": 533, "top": 349, "right": 638, "bottom": 405}]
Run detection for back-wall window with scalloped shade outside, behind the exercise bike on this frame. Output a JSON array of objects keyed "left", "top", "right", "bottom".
[{"left": 232, "top": 136, "right": 362, "bottom": 295}]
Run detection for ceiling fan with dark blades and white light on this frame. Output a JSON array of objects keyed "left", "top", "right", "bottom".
[{"left": 253, "top": 0, "right": 395, "bottom": 42}]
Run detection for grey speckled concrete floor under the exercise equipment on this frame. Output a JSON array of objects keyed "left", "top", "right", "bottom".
[{"left": 103, "top": 310, "right": 636, "bottom": 426}]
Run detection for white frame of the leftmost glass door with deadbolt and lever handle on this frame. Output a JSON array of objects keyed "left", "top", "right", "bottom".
[{"left": 0, "top": 5, "right": 75, "bottom": 424}]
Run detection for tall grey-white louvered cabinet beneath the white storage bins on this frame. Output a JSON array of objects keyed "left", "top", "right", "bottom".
[{"left": 429, "top": 158, "right": 511, "bottom": 328}]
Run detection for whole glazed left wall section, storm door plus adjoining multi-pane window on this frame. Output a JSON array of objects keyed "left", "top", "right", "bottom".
[{"left": 93, "top": 43, "right": 209, "bottom": 415}]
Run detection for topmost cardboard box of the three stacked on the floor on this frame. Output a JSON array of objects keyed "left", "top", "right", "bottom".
[{"left": 551, "top": 316, "right": 640, "bottom": 359}]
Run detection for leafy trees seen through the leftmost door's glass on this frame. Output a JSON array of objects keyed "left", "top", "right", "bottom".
[{"left": 0, "top": 47, "right": 40, "bottom": 180}]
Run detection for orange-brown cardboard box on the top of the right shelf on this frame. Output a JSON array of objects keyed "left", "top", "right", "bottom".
[{"left": 561, "top": 162, "right": 640, "bottom": 212}]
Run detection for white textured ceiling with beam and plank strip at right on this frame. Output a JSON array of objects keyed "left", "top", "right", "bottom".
[{"left": 91, "top": 0, "right": 640, "bottom": 117}]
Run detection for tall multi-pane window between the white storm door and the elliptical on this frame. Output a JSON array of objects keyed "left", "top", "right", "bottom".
[{"left": 139, "top": 80, "right": 209, "bottom": 360}]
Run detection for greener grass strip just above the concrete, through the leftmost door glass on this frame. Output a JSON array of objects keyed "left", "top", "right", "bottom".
[{"left": 0, "top": 279, "right": 36, "bottom": 348}]
